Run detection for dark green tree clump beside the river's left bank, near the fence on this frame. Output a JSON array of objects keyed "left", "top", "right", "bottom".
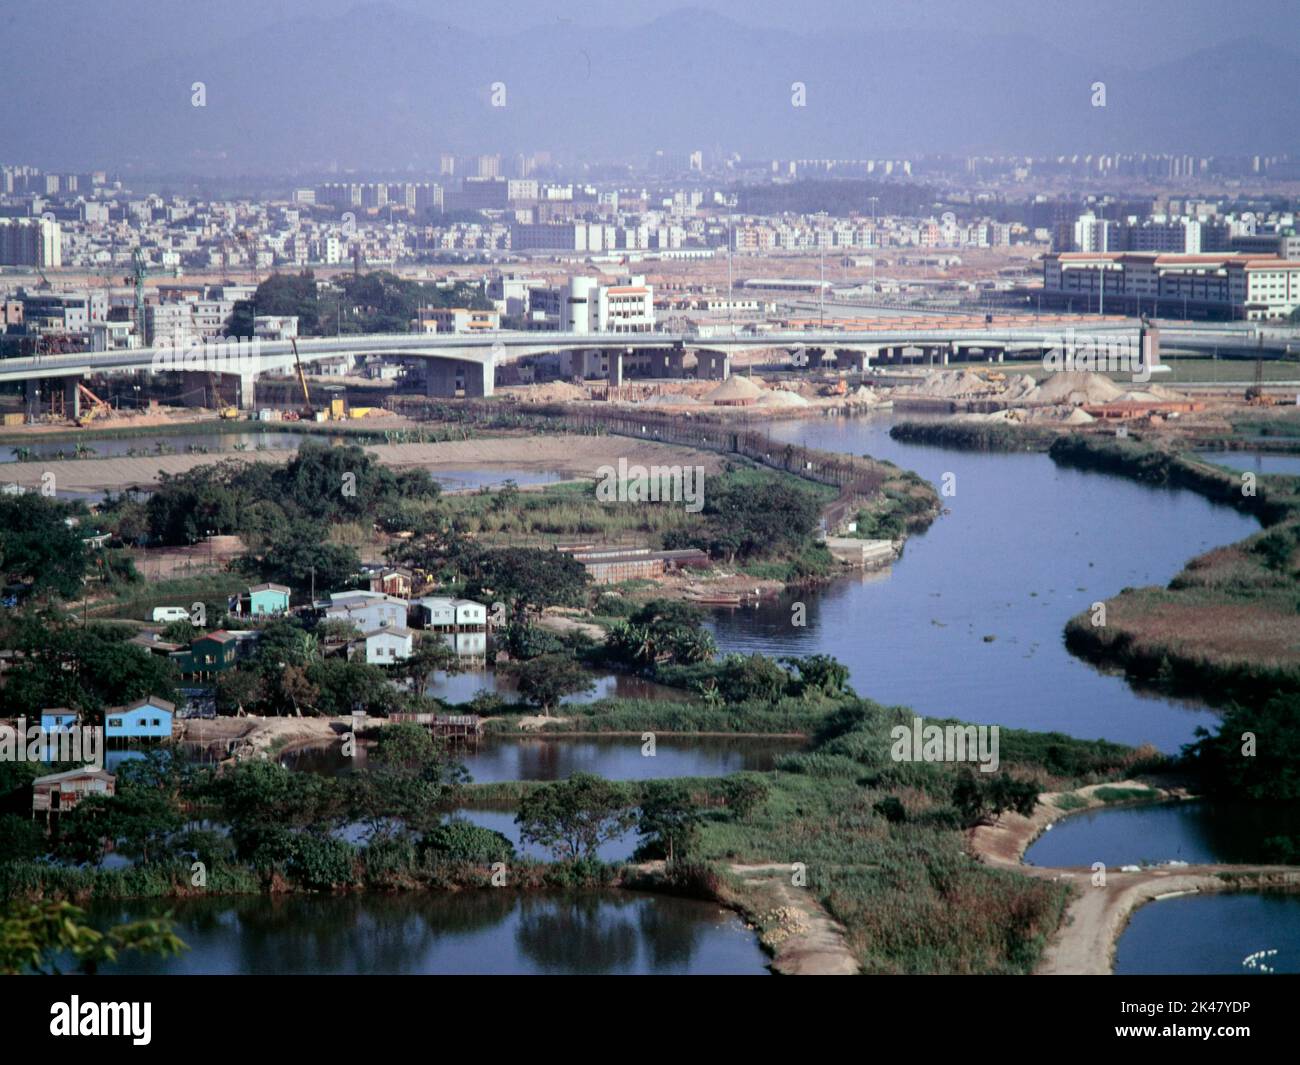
[{"left": 664, "top": 477, "right": 822, "bottom": 563}]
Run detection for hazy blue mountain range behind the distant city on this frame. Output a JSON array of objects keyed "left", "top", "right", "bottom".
[{"left": 0, "top": 5, "right": 1300, "bottom": 173}]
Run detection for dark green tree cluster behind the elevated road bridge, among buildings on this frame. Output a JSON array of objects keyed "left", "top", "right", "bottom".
[{"left": 226, "top": 270, "right": 491, "bottom": 337}]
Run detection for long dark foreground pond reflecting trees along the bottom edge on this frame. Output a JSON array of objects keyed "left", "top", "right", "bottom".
[{"left": 91, "top": 889, "right": 764, "bottom": 974}]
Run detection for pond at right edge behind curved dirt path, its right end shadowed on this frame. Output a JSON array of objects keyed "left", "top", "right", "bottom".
[{"left": 1024, "top": 801, "right": 1300, "bottom": 866}]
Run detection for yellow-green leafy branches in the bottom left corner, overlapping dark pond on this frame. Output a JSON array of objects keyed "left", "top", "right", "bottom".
[{"left": 0, "top": 900, "right": 189, "bottom": 975}]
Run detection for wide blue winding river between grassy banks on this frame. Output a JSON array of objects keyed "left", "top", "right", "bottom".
[{"left": 712, "top": 416, "right": 1258, "bottom": 752}]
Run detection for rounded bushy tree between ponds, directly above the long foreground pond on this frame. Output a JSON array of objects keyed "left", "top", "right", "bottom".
[{"left": 515, "top": 772, "right": 636, "bottom": 861}]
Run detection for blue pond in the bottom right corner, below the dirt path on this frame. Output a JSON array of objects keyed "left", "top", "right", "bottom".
[{"left": 1115, "top": 893, "right": 1300, "bottom": 977}]
